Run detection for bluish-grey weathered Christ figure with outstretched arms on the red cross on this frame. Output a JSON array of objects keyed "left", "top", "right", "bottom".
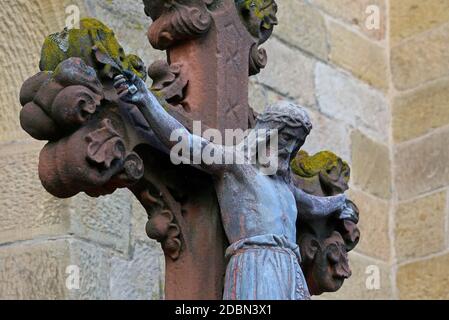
[{"left": 115, "top": 73, "right": 346, "bottom": 300}]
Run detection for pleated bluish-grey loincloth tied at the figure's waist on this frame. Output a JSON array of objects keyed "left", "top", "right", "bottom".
[{"left": 223, "top": 234, "right": 310, "bottom": 300}]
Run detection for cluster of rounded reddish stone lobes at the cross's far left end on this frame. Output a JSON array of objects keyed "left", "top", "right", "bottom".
[{"left": 20, "top": 58, "right": 103, "bottom": 140}]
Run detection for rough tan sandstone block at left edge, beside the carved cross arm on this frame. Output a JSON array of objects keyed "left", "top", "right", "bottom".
[{"left": 0, "top": 142, "right": 70, "bottom": 243}]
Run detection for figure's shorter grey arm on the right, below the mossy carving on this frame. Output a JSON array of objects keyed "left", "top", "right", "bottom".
[{"left": 295, "top": 188, "right": 347, "bottom": 220}]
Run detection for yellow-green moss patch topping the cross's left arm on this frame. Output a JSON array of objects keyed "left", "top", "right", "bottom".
[{"left": 40, "top": 18, "right": 146, "bottom": 79}]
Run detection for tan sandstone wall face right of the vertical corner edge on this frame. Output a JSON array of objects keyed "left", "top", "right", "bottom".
[{"left": 390, "top": 0, "right": 449, "bottom": 299}]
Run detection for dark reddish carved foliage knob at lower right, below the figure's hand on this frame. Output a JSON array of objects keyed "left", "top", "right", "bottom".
[{"left": 302, "top": 232, "right": 351, "bottom": 295}]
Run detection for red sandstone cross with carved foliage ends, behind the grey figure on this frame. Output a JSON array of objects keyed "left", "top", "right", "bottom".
[{"left": 20, "top": 0, "right": 359, "bottom": 299}]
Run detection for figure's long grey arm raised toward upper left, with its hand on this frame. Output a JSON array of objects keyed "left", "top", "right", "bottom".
[{"left": 114, "top": 71, "right": 224, "bottom": 173}]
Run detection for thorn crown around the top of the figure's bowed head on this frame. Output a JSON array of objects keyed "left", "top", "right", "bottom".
[{"left": 257, "top": 102, "right": 312, "bottom": 133}]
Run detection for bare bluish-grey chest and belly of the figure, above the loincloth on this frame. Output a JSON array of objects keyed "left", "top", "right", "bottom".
[{"left": 215, "top": 165, "right": 297, "bottom": 243}]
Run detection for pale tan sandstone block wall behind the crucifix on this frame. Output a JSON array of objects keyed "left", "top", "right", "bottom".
[{"left": 0, "top": 0, "right": 449, "bottom": 299}]
